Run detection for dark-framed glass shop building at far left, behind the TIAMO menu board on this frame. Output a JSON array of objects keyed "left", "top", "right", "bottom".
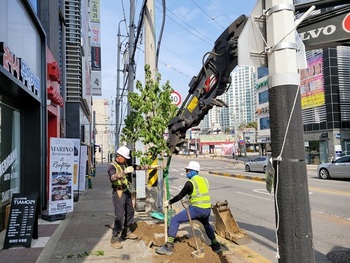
[{"left": 0, "top": 0, "right": 47, "bottom": 231}]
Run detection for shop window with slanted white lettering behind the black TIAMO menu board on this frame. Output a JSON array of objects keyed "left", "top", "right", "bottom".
[{"left": 0, "top": 102, "right": 21, "bottom": 231}]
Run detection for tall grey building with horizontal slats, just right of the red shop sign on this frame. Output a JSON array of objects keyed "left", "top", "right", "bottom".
[{"left": 63, "top": 0, "right": 92, "bottom": 145}]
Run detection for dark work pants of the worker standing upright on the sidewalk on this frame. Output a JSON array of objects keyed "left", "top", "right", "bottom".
[{"left": 112, "top": 190, "right": 135, "bottom": 236}]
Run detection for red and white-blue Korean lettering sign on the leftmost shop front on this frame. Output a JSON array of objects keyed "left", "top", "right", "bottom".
[{"left": 0, "top": 42, "right": 40, "bottom": 97}]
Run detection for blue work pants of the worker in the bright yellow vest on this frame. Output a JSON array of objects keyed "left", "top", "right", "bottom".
[{"left": 168, "top": 206, "right": 215, "bottom": 243}]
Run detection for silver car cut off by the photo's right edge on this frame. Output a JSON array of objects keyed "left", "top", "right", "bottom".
[{"left": 317, "top": 155, "right": 350, "bottom": 179}]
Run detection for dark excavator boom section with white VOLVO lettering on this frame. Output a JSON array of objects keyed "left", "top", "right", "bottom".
[{"left": 298, "top": 11, "right": 350, "bottom": 50}]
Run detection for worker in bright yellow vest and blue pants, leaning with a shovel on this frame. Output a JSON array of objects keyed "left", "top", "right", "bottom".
[{"left": 156, "top": 161, "right": 221, "bottom": 255}]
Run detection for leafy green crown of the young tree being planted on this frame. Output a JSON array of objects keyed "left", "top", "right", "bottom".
[{"left": 121, "top": 65, "right": 177, "bottom": 165}]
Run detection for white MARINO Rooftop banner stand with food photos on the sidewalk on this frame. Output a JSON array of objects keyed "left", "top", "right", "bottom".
[{"left": 48, "top": 138, "right": 74, "bottom": 215}]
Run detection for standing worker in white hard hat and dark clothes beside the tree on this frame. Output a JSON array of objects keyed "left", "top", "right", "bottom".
[{"left": 107, "top": 146, "right": 138, "bottom": 249}]
